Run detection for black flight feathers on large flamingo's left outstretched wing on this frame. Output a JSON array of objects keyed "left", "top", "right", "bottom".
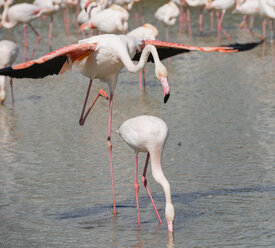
[{"left": 0, "top": 55, "right": 67, "bottom": 78}]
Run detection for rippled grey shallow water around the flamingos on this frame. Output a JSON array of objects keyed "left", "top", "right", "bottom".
[{"left": 0, "top": 1, "right": 275, "bottom": 248}]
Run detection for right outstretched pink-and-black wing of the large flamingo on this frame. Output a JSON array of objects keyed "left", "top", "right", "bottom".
[{"left": 132, "top": 40, "right": 263, "bottom": 62}]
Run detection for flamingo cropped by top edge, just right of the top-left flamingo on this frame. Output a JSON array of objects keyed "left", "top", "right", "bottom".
[{"left": 33, "top": 0, "right": 61, "bottom": 51}]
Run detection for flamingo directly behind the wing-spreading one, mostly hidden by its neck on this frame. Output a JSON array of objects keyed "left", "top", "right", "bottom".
[{"left": 127, "top": 23, "right": 159, "bottom": 90}]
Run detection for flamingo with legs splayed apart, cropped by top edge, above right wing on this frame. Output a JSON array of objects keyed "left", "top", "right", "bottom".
[{"left": 205, "top": 0, "right": 235, "bottom": 42}]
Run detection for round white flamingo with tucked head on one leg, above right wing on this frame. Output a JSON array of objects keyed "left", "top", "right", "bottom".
[{"left": 155, "top": 1, "right": 180, "bottom": 41}]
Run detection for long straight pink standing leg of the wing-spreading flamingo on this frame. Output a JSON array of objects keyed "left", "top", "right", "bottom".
[{"left": 107, "top": 93, "right": 117, "bottom": 215}]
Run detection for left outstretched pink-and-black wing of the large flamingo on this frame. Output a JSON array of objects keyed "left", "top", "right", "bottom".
[{"left": 0, "top": 43, "right": 96, "bottom": 78}]
